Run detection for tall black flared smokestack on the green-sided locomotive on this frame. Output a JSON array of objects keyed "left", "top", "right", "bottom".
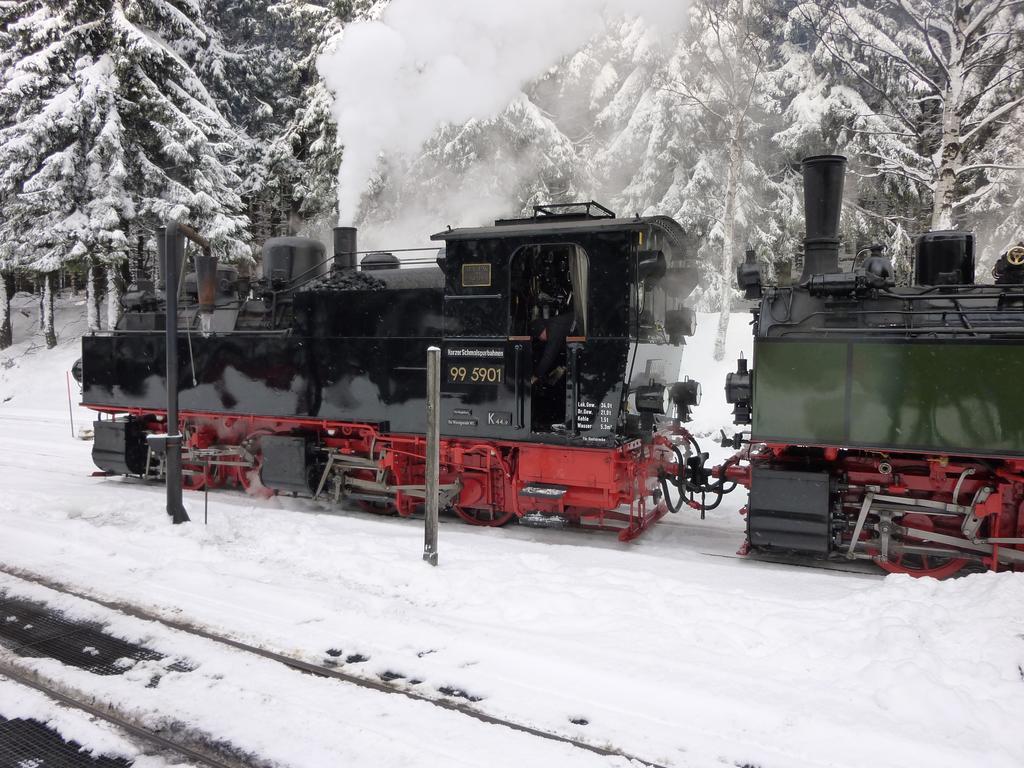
[{"left": 800, "top": 155, "right": 846, "bottom": 283}]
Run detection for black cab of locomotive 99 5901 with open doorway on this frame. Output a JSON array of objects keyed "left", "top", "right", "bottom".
[{"left": 434, "top": 203, "right": 694, "bottom": 446}]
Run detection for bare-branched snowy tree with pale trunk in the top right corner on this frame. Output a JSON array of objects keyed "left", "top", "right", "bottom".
[{"left": 802, "top": 0, "right": 1024, "bottom": 264}]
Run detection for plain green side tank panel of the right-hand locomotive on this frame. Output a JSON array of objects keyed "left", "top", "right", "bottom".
[{"left": 753, "top": 338, "right": 1024, "bottom": 456}]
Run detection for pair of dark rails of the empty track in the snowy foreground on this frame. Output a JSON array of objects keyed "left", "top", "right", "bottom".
[{"left": 0, "top": 563, "right": 666, "bottom": 768}]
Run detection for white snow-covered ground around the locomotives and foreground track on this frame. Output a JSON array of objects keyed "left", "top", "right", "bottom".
[{"left": 0, "top": 301, "right": 1024, "bottom": 768}]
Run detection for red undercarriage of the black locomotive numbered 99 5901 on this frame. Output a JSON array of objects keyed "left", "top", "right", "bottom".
[{"left": 90, "top": 407, "right": 679, "bottom": 541}]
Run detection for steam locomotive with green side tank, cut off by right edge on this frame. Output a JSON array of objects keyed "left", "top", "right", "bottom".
[{"left": 716, "top": 156, "right": 1024, "bottom": 578}]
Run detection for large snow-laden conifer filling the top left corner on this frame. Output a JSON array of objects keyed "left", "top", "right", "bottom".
[{"left": 0, "top": 0, "right": 250, "bottom": 338}]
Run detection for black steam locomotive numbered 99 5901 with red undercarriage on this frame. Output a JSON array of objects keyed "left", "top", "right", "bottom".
[{"left": 80, "top": 202, "right": 723, "bottom": 541}]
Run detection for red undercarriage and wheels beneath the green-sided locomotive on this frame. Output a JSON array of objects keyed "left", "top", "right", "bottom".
[{"left": 724, "top": 443, "right": 1024, "bottom": 578}]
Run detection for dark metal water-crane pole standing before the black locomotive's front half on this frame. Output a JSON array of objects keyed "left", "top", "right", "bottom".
[{"left": 158, "top": 221, "right": 188, "bottom": 525}]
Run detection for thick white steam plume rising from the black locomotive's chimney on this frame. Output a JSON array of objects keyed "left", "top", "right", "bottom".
[{"left": 319, "top": 0, "right": 687, "bottom": 224}]
